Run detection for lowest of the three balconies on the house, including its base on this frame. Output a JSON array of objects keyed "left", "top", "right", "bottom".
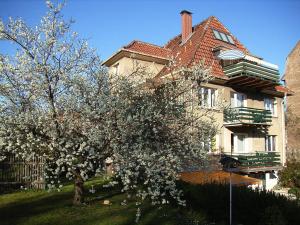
[{"left": 222, "top": 152, "right": 282, "bottom": 173}]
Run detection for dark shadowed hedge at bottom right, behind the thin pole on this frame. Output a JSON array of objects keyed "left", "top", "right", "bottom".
[{"left": 180, "top": 183, "right": 300, "bottom": 225}]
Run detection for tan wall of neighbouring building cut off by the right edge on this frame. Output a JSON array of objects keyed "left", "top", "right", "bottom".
[{"left": 282, "top": 41, "right": 300, "bottom": 160}]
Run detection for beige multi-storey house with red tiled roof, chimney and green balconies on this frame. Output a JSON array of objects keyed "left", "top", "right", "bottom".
[{"left": 104, "top": 10, "right": 289, "bottom": 189}]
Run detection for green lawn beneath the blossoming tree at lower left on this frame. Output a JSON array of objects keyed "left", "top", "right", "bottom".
[{"left": 0, "top": 180, "right": 203, "bottom": 225}]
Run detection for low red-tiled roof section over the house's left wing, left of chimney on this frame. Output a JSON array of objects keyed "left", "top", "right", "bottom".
[{"left": 124, "top": 40, "right": 171, "bottom": 58}]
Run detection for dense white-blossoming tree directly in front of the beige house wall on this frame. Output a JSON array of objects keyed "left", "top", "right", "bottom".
[{"left": 106, "top": 60, "right": 221, "bottom": 218}]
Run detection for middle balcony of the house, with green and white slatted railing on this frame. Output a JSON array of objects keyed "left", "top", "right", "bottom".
[{"left": 224, "top": 107, "right": 272, "bottom": 127}]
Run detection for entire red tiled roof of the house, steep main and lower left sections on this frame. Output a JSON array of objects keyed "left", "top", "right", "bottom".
[{"left": 116, "top": 16, "right": 249, "bottom": 78}]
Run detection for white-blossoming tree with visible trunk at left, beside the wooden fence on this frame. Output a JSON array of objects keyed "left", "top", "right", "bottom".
[{"left": 0, "top": 2, "right": 109, "bottom": 204}]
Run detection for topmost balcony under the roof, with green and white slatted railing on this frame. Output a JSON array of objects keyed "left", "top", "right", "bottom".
[{"left": 223, "top": 60, "right": 280, "bottom": 89}]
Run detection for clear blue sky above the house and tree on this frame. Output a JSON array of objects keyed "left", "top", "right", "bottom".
[{"left": 0, "top": 0, "right": 300, "bottom": 73}]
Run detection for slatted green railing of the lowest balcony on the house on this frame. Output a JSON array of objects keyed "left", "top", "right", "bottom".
[{"left": 224, "top": 152, "right": 281, "bottom": 169}]
